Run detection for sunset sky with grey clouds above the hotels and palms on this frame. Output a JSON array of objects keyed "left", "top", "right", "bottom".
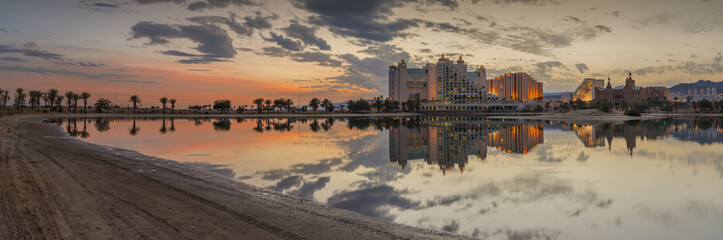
[{"left": 0, "top": 0, "right": 723, "bottom": 106}]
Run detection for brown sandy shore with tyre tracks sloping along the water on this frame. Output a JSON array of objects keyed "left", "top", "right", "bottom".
[{"left": 0, "top": 114, "right": 466, "bottom": 239}]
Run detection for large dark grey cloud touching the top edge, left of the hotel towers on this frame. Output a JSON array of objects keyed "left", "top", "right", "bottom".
[{"left": 292, "top": 0, "right": 417, "bottom": 42}]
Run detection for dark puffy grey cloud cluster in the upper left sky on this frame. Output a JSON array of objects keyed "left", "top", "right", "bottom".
[{"left": 129, "top": 21, "right": 236, "bottom": 63}]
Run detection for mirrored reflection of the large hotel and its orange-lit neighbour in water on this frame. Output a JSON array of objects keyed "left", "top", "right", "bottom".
[{"left": 389, "top": 116, "right": 544, "bottom": 173}]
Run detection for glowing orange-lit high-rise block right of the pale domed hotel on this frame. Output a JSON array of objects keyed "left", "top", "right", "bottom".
[{"left": 487, "top": 72, "right": 542, "bottom": 102}]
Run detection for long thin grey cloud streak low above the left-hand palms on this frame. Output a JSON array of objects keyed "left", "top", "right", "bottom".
[{"left": 0, "top": 66, "right": 160, "bottom": 84}]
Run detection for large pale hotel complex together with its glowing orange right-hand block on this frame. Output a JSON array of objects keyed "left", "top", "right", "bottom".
[{"left": 389, "top": 54, "right": 542, "bottom": 111}]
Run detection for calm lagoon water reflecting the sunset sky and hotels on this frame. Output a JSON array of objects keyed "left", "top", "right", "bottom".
[{"left": 52, "top": 117, "right": 723, "bottom": 239}]
